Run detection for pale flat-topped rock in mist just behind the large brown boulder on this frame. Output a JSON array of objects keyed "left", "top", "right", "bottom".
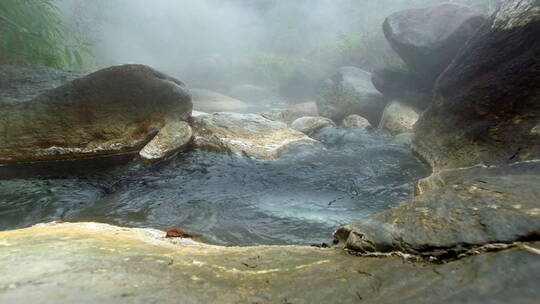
[{"left": 189, "top": 89, "right": 248, "bottom": 113}]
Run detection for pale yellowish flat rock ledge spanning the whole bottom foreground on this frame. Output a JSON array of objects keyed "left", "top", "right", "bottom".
[{"left": 0, "top": 223, "right": 540, "bottom": 304}]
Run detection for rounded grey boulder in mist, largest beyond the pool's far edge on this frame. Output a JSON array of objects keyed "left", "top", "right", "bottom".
[{"left": 317, "top": 67, "right": 386, "bottom": 125}]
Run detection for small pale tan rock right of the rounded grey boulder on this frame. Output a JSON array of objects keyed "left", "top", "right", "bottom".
[{"left": 379, "top": 101, "right": 419, "bottom": 134}]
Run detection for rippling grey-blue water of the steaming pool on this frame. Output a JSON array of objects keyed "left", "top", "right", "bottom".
[{"left": 0, "top": 128, "right": 427, "bottom": 245}]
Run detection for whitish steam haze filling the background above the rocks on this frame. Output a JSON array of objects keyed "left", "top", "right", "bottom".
[{"left": 59, "top": 0, "right": 497, "bottom": 92}]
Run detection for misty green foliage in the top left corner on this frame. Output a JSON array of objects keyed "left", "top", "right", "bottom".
[{"left": 0, "top": 0, "right": 91, "bottom": 69}]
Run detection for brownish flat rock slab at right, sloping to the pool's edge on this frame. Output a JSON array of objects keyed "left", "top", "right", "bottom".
[{"left": 335, "top": 161, "right": 540, "bottom": 257}]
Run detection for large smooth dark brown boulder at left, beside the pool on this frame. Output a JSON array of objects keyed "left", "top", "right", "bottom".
[{"left": 0, "top": 65, "right": 192, "bottom": 163}]
